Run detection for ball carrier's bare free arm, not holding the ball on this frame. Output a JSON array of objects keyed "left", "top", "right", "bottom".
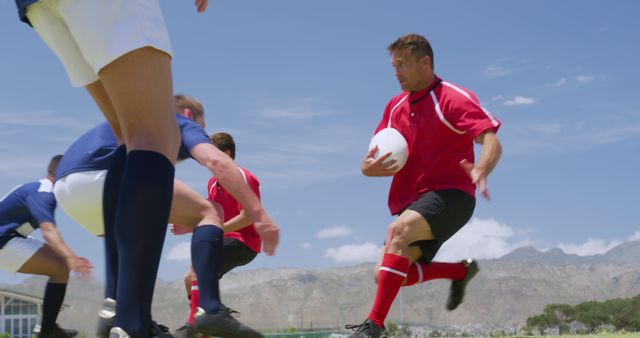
[{"left": 460, "top": 131, "right": 502, "bottom": 200}]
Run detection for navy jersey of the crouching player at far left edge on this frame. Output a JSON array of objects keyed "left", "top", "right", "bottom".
[{"left": 0, "top": 179, "right": 56, "bottom": 248}]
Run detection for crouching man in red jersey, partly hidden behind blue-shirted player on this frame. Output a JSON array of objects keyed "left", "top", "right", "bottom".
[{"left": 172, "top": 132, "right": 262, "bottom": 338}]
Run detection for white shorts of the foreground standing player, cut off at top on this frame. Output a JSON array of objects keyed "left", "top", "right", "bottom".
[{"left": 27, "top": 0, "right": 172, "bottom": 87}]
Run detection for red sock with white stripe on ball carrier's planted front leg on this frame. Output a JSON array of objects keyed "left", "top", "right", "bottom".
[{"left": 369, "top": 253, "right": 409, "bottom": 327}]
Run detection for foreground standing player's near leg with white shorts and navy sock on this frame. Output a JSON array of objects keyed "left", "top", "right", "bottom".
[{"left": 27, "top": 0, "right": 175, "bottom": 337}]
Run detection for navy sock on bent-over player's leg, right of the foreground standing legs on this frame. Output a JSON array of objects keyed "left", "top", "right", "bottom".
[{"left": 191, "top": 224, "right": 224, "bottom": 313}]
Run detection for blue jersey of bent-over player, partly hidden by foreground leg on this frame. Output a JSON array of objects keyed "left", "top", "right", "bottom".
[{"left": 56, "top": 114, "right": 209, "bottom": 180}]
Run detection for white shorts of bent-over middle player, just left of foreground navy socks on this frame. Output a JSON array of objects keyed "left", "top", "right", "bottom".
[{"left": 53, "top": 170, "right": 107, "bottom": 236}]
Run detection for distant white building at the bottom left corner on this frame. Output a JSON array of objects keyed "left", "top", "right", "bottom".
[{"left": 0, "top": 289, "right": 69, "bottom": 338}]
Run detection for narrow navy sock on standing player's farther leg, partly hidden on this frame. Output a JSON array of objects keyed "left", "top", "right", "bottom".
[{"left": 102, "top": 145, "right": 127, "bottom": 300}]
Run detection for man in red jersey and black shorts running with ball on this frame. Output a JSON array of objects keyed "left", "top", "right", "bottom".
[{"left": 347, "top": 34, "right": 502, "bottom": 338}]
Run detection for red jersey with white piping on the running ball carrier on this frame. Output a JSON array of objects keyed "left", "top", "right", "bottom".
[{"left": 376, "top": 77, "right": 500, "bottom": 215}]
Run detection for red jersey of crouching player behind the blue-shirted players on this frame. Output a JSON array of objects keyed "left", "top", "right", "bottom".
[{"left": 208, "top": 167, "right": 262, "bottom": 252}]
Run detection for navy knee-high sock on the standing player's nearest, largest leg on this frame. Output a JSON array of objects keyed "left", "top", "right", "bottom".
[{"left": 115, "top": 150, "right": 175, "bottom": 338}]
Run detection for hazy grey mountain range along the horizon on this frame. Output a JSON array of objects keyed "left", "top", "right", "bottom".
[{"left": 1, "top": 241, "right": 640, "bottom": 333}]
